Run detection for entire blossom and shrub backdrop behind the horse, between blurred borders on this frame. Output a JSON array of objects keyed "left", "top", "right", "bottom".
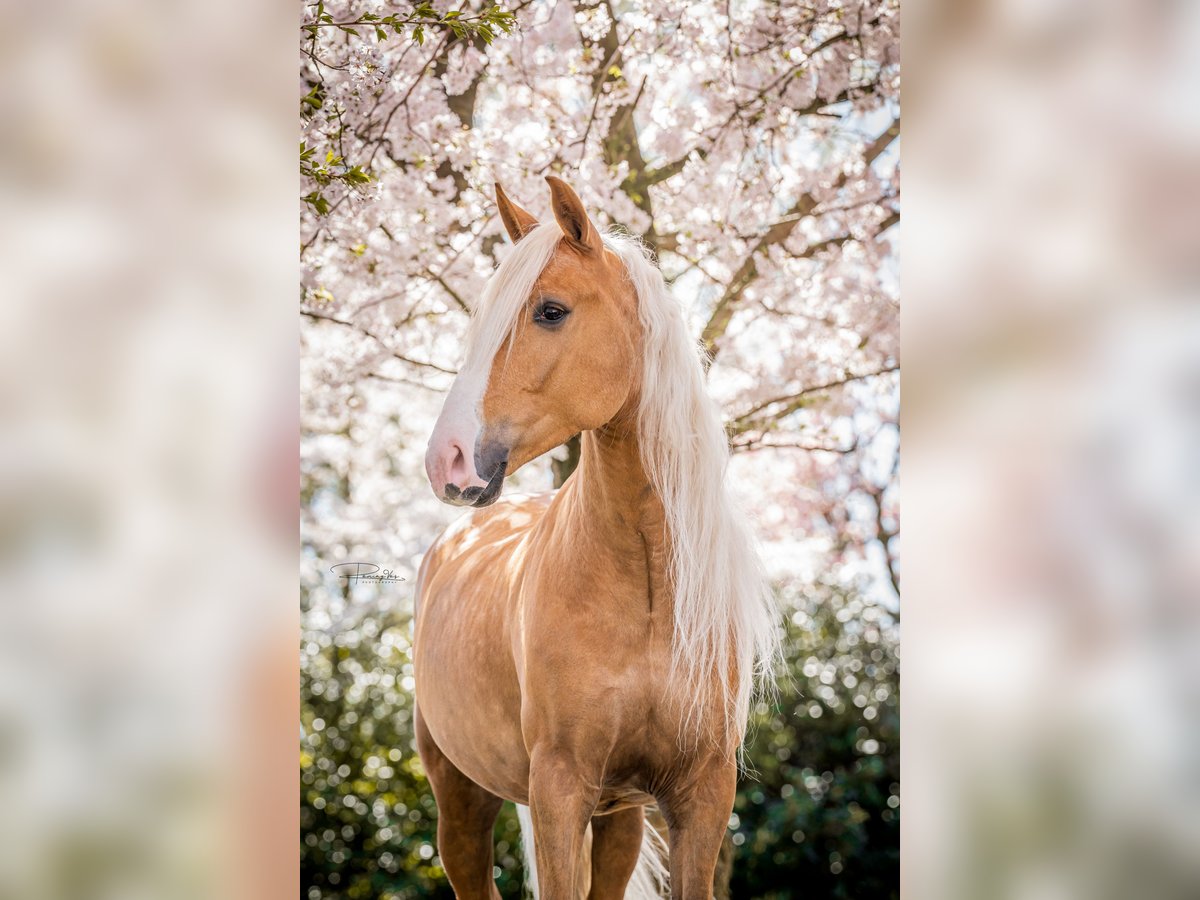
[{"left": 300, "top": 0, "right": 900, "bottom": 900}]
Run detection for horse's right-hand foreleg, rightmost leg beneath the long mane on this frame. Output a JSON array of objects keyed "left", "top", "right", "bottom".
[{"left": 660, "top": 763, "right": 737, "bottom": 900}]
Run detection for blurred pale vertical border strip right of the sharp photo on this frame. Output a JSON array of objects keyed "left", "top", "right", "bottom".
[{"left": 901, "top": 0, "right": 1200, "bottom": 899}]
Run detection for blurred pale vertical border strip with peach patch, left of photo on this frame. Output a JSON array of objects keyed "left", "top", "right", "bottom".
[{"left": 0, "top": 1, "right": 299, "bottom": 898}]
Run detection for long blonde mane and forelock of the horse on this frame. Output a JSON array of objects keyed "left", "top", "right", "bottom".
[{"left": 460, "top": 222, "right": 778, "bottom": 738}]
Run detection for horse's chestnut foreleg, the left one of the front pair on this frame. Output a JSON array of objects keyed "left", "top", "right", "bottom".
[{"left": 529, "top": 752, "right": 600, "bottom": 900}]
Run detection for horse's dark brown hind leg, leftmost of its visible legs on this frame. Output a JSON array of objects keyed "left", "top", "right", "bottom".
[{"left": 414, "top": 710, "right": 503, "bottom": 900}]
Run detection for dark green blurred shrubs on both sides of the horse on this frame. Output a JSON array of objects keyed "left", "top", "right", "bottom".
[{"left": 300, "top": 586, "right": 900, "bottom": 900}]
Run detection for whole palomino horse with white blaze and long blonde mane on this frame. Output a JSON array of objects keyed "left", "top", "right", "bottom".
[{"left": 415, "top": 178, "right": 775, "bottom": 900}]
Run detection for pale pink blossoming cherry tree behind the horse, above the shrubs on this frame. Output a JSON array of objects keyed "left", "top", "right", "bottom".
[{"left": 300, "top": 0, "right": 900, "bottom": 897}]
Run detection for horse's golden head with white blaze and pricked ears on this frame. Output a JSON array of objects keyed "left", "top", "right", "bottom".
[{"left": 425, "top": 175, "right": 641, "bottom": 506}]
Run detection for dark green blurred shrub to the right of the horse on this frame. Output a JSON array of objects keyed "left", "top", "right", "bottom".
[{"left": 731, "top": 587, "right": 900, "bottom": 900}]
